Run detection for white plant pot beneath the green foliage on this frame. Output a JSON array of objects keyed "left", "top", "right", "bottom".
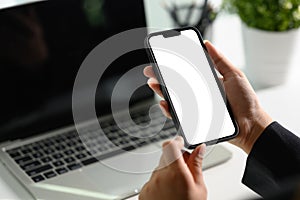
[{"left": 242, "top": 24, "right": 300, "bottom": 89}]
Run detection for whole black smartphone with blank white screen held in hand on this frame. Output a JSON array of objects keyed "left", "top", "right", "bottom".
[{"left": 145, "top": 27, "right": 238, "bottom": 149}]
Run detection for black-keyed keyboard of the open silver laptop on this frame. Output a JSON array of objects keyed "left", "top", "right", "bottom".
[{"left": 7, "top": 109, "right": 176, "bottom": 182}]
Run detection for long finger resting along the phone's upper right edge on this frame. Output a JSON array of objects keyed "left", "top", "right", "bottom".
[{"left": 204, "top": 40, "right": 237, "bottom": 78}]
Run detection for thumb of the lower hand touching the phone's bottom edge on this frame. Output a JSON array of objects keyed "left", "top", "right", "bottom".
[{"left": 188, "top": 144, "right": 206, "bottom": 184}]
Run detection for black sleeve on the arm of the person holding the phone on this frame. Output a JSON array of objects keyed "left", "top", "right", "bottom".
[{"left": 242, "top": 122, "right": 300, "bottom": 197}]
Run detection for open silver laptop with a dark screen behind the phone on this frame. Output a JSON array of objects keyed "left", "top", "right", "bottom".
[{"left": 0, "top": 0, "right": 231, "bottom": 200}]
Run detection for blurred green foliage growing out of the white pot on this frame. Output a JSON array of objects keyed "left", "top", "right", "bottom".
[{"left": 222, "top": 0, "right": 300, "bottom": 31}]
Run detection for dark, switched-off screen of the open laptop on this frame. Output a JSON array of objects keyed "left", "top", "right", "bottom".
[{"left": 0, "top": 0, "right": 153, "bottom": 141}]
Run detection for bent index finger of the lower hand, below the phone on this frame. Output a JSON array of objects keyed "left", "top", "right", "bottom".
[{"left": 162, "top": 136, "right": 185, "bottom": 167}]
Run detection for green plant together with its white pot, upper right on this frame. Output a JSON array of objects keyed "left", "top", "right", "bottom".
[{"left": 223, "top": 0, "right": 300, "bottom": 88}]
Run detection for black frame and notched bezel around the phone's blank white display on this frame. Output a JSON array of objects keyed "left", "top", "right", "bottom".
[{"left": 145, "top": 27, "right": 239, "bottom": 149}]
